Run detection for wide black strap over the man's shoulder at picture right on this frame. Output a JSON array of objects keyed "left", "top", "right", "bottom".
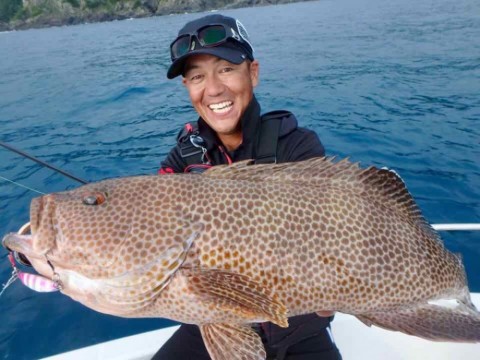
[{"left": 255, "top": 110, "right": 291, "bottom": 164}]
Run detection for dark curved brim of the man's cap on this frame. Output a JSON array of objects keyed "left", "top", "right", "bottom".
[{"left": 167, "top": 46, "right": 248, "bottom": 79}]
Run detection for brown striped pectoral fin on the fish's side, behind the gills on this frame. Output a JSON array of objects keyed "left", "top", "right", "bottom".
[{"left": 182, "top": 269, "right": 288, "bottom": 327}]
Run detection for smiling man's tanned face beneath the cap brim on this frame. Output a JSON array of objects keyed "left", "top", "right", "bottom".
[{"left": 183, "top": 54, "right": 258, "bottom": 139}]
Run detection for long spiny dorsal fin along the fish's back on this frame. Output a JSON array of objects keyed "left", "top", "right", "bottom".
[{"left": 204, "top": 157, "right": 439, "bottom": 239}]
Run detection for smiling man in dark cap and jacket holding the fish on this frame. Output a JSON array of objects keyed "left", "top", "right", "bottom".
[{"left": 154, "top": 15, "right": 341, "bottom": 360}]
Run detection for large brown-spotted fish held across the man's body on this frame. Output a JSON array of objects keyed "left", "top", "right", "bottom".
[{"left": 4, "top": 158, "right": 480, "bottom": 360}]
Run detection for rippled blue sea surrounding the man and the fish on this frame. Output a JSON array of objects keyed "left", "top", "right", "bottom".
[{"left": 0, "top": 0, "right": 480, "bottom": 359}]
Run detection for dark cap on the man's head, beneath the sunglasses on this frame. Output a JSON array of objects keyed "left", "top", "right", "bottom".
[{"left": 167, "top": 14, "right": 254, "bottom": 79}]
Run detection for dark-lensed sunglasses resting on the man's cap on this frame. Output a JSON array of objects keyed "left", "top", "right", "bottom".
[{"left": 170, "top": 24, "right": 248, "bottom": 61}]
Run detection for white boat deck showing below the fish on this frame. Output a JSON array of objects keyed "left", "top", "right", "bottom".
[{"left": 43, "top": 293, "right": 480, "bottom": 360}]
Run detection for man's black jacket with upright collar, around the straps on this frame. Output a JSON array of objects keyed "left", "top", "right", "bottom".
[{"left": 160, "top": 97, "right": 325, "bottom": 173}]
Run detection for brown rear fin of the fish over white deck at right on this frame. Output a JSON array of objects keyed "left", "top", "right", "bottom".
[{"left": 357, "top": 303, "right": 480, "bottom": 342}]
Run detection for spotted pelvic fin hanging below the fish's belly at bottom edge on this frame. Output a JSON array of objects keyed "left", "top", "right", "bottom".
[{"left": 200, "top": 324, "right": 266, "bottom": 360}]
